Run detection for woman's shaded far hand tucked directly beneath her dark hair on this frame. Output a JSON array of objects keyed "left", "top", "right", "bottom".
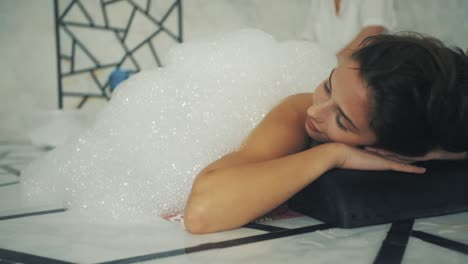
[{"left": 365, "top": 147, "right": 467, "bottom": 163}]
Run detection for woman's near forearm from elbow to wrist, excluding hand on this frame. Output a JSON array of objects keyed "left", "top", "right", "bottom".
[{"left": 184, "top": 144, "right": 335, "bottom": 233}]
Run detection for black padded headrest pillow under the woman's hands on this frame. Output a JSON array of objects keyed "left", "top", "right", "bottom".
[{"left": 288, "top": 161, "right": 468, "bottom": 228}]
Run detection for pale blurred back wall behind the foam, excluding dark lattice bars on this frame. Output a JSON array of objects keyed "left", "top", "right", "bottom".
[{"left": 0, "top": 0, "right": 468, "bottom": 141}]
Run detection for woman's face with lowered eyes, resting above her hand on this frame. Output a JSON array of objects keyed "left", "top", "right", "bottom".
[{"left": 305, "top": 60, "right": 376, "bottom": 146}]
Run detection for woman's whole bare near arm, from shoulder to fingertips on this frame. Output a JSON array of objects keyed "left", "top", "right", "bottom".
[{"left": 184, "top": 94, "right": 424, "bottom": 234}]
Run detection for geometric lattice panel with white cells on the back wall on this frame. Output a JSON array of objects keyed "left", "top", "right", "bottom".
[{"left": 54, "top": 0, "right": 182, "bottom": 109}]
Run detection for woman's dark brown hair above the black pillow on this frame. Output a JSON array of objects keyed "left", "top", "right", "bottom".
[{"left": 351, "top": 32, "right": 468, "bottom": 156}]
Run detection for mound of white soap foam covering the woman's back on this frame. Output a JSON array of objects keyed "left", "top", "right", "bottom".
[{"left": 22, "top": 29, "right": 334, "bottom": 222}]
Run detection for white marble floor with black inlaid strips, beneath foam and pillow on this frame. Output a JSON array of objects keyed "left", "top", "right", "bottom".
[{"left": 0, "top": 141, "right": 468, "bottom": 264}]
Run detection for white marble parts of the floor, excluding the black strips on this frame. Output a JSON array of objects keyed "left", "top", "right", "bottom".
[{"left": 0, "top": 143, "right": 468, "bottom": 264}]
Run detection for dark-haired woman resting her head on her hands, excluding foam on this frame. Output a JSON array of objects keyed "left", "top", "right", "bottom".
[{"left": 184, "top": 34, "right": 468, "bottom": 233}]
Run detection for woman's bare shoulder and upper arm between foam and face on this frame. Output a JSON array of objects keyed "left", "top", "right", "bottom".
[{"left": 199, "top": 93, "right": 312, "bottom": 174}]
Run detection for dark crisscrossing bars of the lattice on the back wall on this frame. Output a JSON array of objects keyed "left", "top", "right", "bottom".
[{"left": 54, "top": 0, "right": 183, "bottom": 109}]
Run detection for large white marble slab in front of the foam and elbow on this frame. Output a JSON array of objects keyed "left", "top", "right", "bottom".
[{"left": 0, "top": 209, "right": 264, "bottom": 263}]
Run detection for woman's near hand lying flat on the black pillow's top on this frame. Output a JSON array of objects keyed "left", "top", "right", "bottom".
[{"left": 328, "top": 143, "right": 426, "bottom": 174}]
